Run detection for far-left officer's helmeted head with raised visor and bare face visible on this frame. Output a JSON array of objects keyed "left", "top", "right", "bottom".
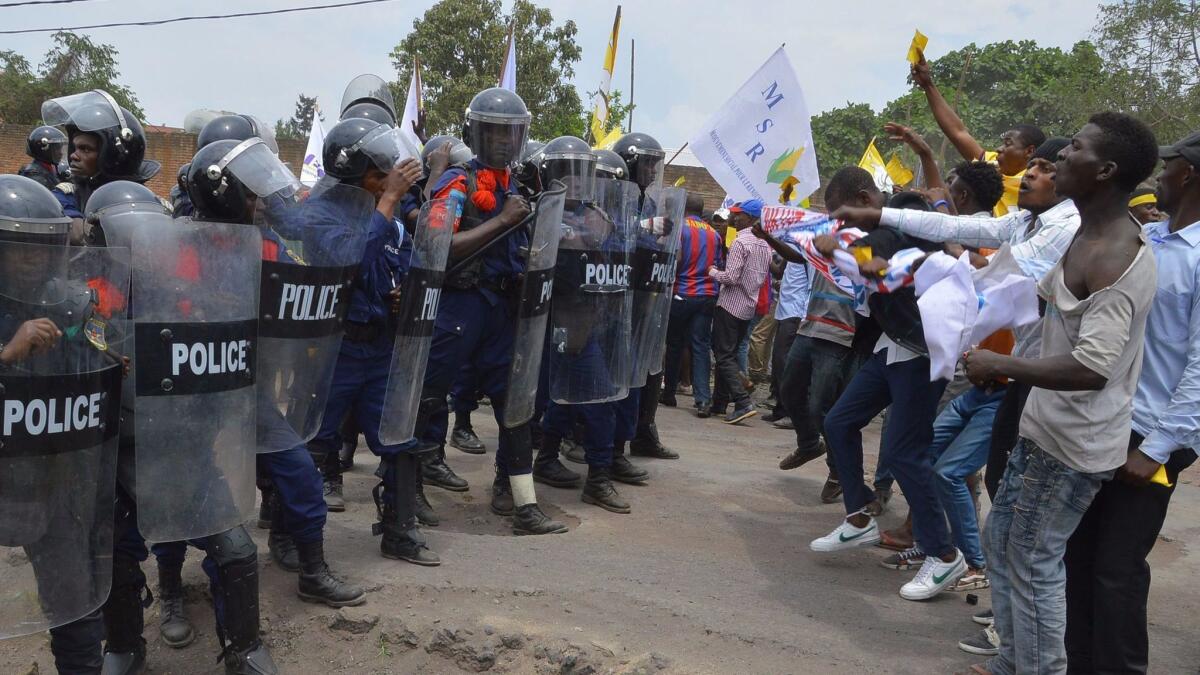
[{"left": 42, "top": 89, "right": 162, "bottom": 245}]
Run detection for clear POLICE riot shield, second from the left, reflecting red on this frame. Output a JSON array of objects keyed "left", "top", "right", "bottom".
[{"left": 130, "top": 219, "right": 263, "bottom": 542}]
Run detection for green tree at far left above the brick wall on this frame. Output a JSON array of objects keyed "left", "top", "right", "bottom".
[{"left": 0, "top": 31, "right": 145, "bottom": 124}]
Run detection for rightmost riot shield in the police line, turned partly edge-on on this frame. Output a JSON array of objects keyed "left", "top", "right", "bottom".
[{"left": 629, "top": 187, "right": 688, "bottom": 388}]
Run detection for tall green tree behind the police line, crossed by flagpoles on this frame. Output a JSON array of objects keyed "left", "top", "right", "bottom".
[{"left": 391, "top": 0, "right": 583, "bottom": 139}]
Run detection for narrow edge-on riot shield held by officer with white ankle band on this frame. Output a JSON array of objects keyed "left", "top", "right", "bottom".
[{"left": 502, "top": 181, "right": 566, "bottom": 429}]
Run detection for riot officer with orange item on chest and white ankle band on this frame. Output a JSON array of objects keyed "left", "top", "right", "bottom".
[{"left": 416, "top": 88, "right": 566, "bottom": 534}]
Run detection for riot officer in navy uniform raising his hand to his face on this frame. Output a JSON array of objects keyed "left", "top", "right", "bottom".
[{"left": 308, "top": 118, "right": 440, "bottom": 566}]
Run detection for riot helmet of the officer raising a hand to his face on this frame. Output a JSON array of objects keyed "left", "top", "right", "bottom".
[{"left": 322, "top": 118, "right": 420, "bottom": 184}]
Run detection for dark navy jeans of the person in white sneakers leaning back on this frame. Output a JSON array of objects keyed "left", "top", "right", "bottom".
[{"left": 824, "top": 351, "right": 954, "bottom": 556}]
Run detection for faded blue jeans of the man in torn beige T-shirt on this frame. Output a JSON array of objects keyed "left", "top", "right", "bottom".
[{"left": 984, "top": 438, "right": 1114, "bottom": 675}]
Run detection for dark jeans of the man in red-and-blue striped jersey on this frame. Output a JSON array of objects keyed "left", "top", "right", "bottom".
[{"left": 662, "top": 297, "right": 716, "bottom": 408}]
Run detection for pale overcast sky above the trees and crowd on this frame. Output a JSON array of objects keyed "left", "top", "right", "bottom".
[{"left": 0, "top": 0, "right": 1097, "bottom": 147}]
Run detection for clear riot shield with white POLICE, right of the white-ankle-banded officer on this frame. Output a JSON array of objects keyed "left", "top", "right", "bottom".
[{"left": 545, "top": 180, "right": 638, "bottom": 404}]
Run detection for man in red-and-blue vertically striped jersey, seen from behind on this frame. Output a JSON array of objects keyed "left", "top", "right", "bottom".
[{"left": 660, "top": 193, "right": 725, "bottom": 417}]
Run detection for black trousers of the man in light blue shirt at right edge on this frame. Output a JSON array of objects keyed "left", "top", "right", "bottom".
[{"left": 1063, "top": 432, "right": 1195, "bottom": 674}]
